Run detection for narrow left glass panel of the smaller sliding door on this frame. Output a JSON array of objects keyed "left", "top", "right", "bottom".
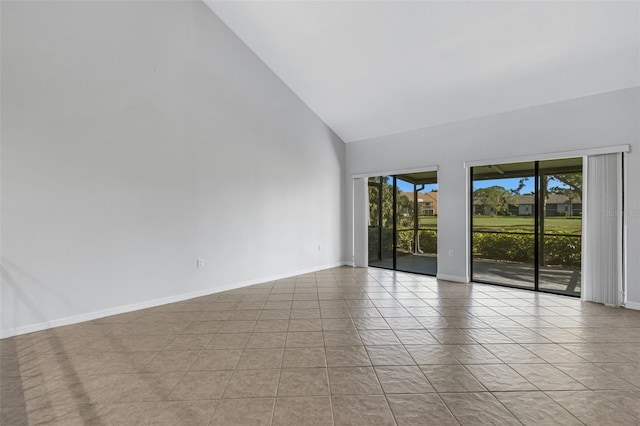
[{"left": 369, "top": 176, "right": 393, "bottom": 269}]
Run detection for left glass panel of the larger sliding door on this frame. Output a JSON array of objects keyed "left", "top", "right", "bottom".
[{"left": 471, "top": 162, "right": 535, "bottom": 289}]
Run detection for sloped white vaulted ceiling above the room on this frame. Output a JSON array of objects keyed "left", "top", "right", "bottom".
[{"left": 207, "top": 0, "right": 640, "bottom": 142}]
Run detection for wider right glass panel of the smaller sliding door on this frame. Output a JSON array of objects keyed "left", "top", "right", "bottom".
[{"left": 396, "top": 171, "right": 438, "bottom": 275}]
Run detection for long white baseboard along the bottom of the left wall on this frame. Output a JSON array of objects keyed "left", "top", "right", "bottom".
[{"left": 0, "top": 261, "right": 351, "bottom": 339}]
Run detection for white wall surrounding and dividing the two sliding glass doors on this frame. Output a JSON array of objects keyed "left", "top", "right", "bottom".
[{"left": 345, "top": 87, "right": 640, "bottom": 302}]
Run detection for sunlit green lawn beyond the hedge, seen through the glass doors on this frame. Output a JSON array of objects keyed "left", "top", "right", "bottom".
[{"left": 420, "top": 215, "right": 582, "bottom": 235}]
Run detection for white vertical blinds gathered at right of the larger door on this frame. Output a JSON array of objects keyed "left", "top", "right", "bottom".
[{"left": 582, "top": 153, "right": 624, "bottom": 306}]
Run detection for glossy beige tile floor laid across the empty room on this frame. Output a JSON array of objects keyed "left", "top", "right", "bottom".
[{"left": 0, "top": 267, "right": 640, "bottom": 426}]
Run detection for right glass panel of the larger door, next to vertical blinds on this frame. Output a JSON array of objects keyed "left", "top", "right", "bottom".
[{"left": 538, "top": 158, "right": 582, "bottom": 296}]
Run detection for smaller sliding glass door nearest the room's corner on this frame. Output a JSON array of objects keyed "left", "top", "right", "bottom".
[{"left": 369, "top": 171, "right": 438, "bottom": 275}]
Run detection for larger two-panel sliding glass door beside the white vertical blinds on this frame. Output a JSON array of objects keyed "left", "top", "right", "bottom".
[{"left": 471, "top": 158, "right": 582, "bottom": 295}]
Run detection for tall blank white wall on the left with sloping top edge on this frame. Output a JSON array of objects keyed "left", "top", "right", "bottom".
[{"left": 0, "top": 1, "right": 345, "bottom": 336}]
